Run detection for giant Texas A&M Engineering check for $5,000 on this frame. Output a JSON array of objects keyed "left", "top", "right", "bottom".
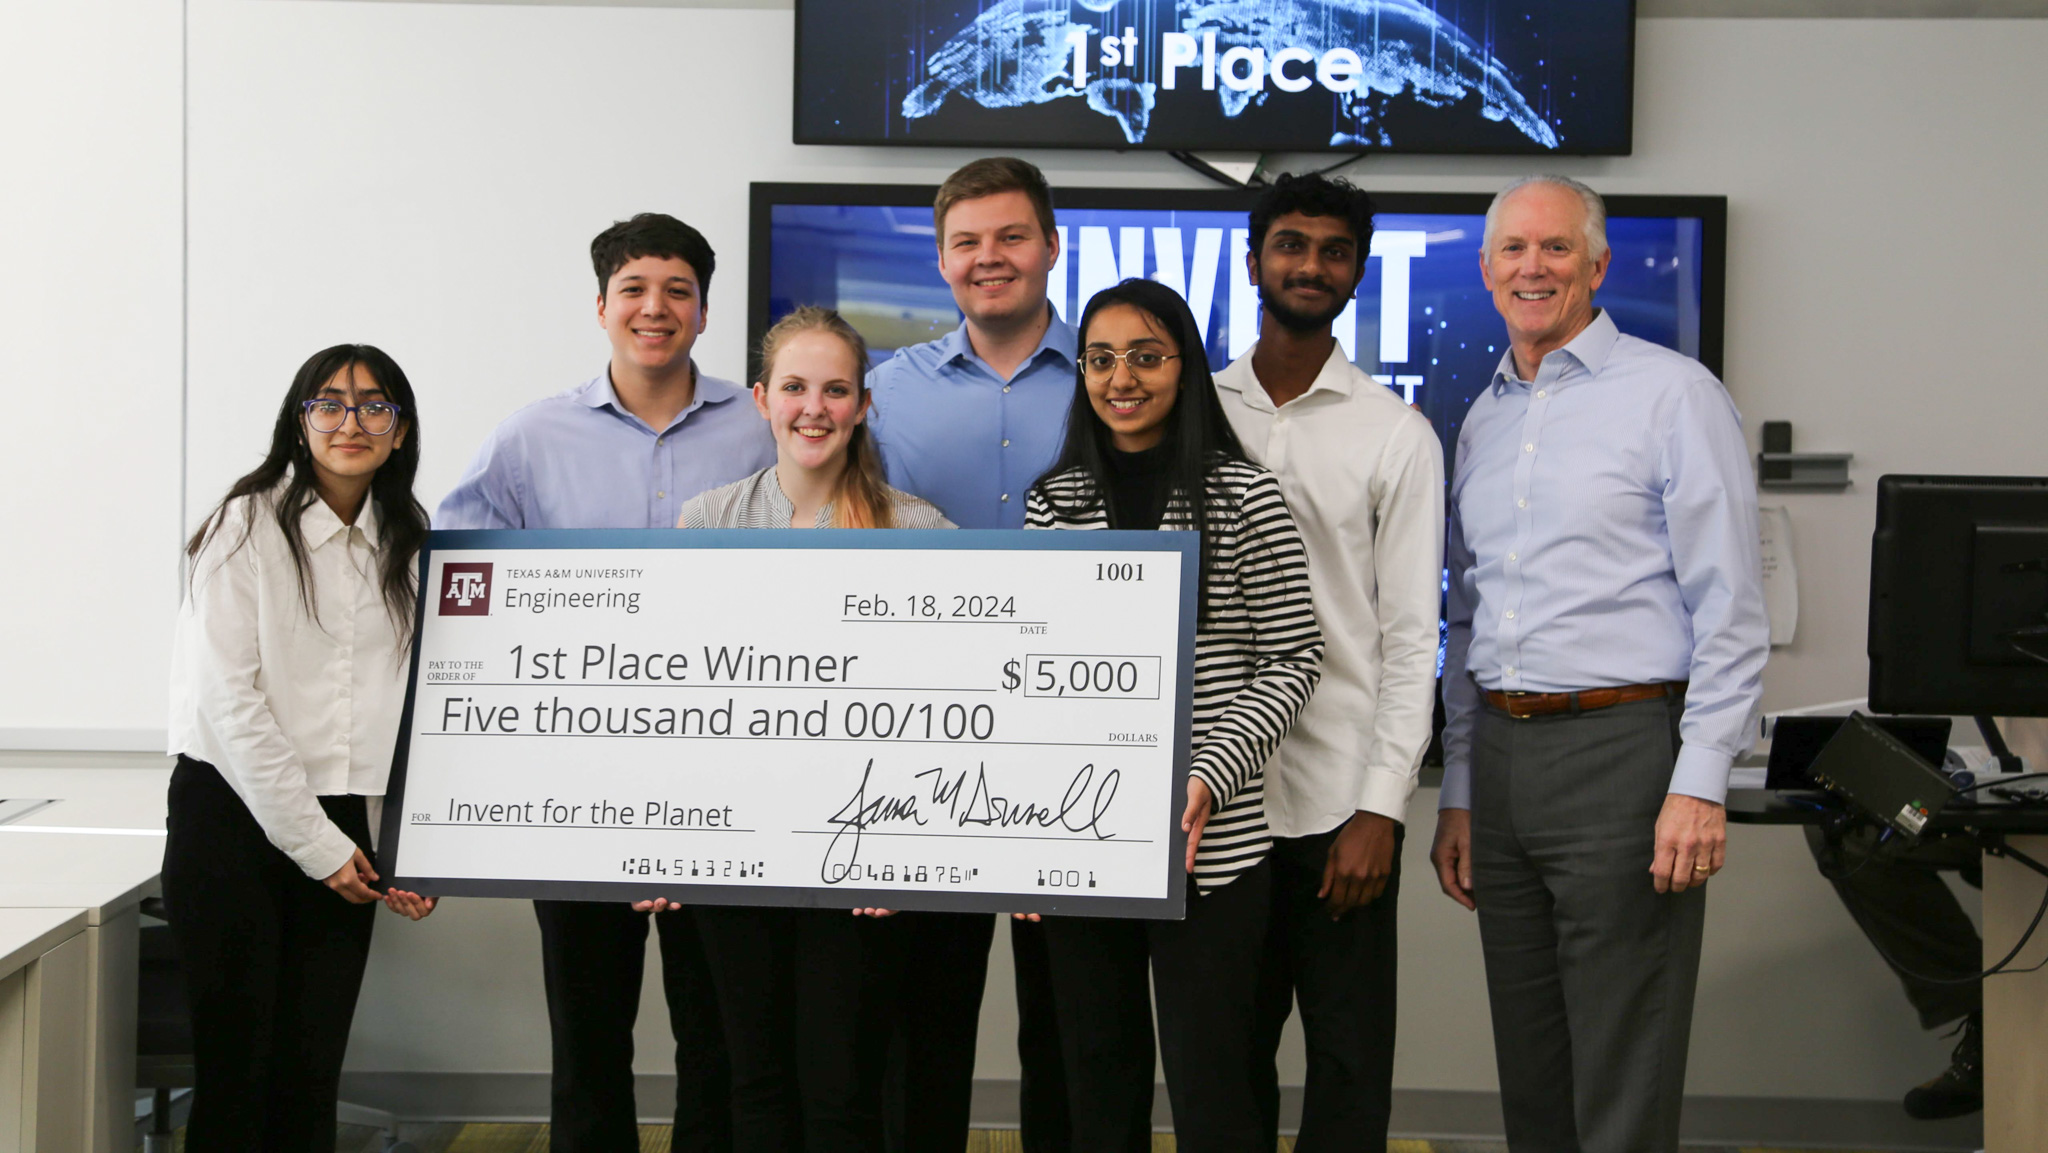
[{"left": 383, "top": 530, "right": 1198, "bottom": 917}]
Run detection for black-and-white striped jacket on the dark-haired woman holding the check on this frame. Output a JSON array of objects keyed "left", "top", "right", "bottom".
[{"left": 1024, "top": 461, "right": 1323, "bottom": 893}]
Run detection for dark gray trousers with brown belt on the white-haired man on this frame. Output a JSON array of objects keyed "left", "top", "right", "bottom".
[{"left": 1473, "top": 698, "right": 1706, "bottom": 1153}]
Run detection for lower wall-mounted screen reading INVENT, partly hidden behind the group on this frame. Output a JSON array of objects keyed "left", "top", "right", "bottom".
[{"left": 748, "top": 184, "right": 1729, "bottom": 473}]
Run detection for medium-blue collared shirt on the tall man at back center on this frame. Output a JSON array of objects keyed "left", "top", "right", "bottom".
[{"left": 868, "top": 313, "right": 1075, "bottom": 528}]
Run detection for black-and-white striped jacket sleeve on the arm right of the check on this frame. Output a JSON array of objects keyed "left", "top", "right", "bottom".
[{"left": 1188, "top": 469, "right": 1323, "bottom": 809}]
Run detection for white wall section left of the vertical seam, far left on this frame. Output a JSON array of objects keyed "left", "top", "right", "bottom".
[{"left": 0, "top": 0, "right": 184, "bottom": 748}]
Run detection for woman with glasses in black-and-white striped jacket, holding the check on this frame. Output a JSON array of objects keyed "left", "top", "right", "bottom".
[{"left": 1026, "top": 281, "right": 1323, "bottom": 1153}]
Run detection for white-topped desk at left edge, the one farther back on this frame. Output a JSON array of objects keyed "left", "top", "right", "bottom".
[{"left": 0, "top": 768, "right": 170, "bottom": 1153}]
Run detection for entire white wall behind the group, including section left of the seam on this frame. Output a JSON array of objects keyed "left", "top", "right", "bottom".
[{"left": 0, "top": 0, "right": 2048, "bottom": 1100}]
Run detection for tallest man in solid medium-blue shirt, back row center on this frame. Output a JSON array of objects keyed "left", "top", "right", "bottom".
[{"left": 868, "top": 158, "right": 1075, "bottom": 1153}]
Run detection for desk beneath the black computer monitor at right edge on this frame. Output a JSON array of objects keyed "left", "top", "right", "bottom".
[{"left": 1729, "top": 788, "right": 2048, "bottom": 1153}]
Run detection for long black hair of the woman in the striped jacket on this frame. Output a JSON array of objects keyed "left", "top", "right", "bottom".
[{"left": 1034, "top": 279, "right": 1247, "bottom": 621}]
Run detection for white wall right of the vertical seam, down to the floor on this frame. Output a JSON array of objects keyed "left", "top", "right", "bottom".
[{"left": 193, "top": 0, "right": 2048, "bottom": 1098}]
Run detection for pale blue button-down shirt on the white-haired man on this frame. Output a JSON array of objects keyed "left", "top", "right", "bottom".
[{"left": 1442, "top": 311, "right": 1769, "bottom": 809}]
